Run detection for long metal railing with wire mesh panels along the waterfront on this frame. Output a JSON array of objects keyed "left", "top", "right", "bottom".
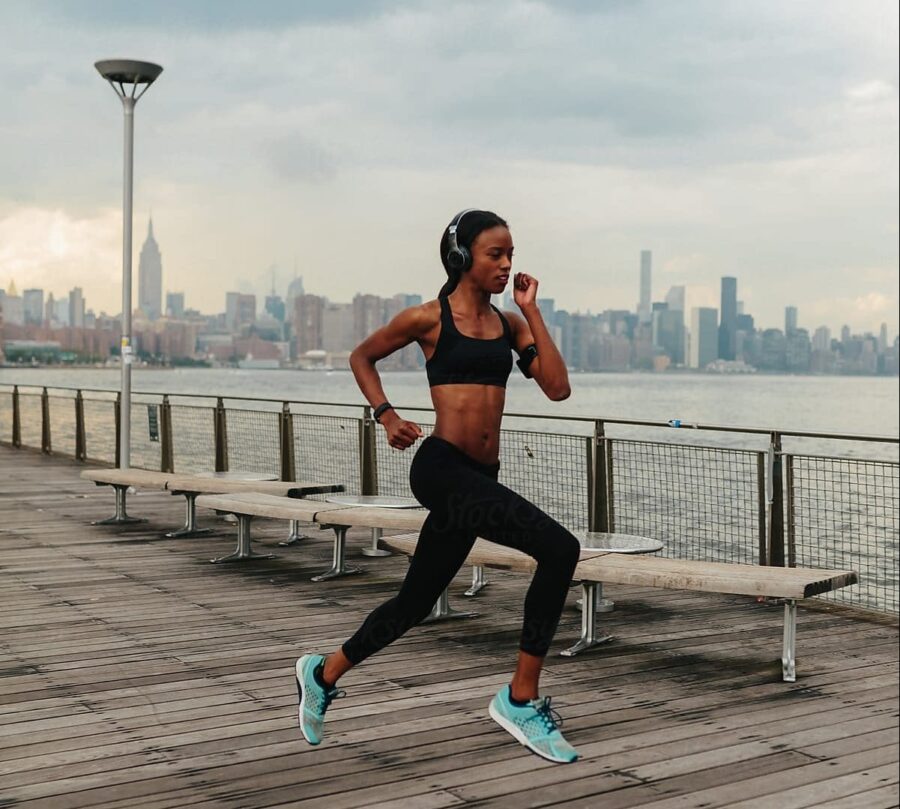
[{"left": 0, "top": 386, "right": 900, "bottom": 613}]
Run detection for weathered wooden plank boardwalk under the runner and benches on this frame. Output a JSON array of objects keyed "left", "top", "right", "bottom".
[{"left": 0, "top": 447, "right": 898, "bottom": 809}]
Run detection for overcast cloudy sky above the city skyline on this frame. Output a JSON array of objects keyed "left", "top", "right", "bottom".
[{"left": 0, "top": 0, "right": 898, "bottom": 335}]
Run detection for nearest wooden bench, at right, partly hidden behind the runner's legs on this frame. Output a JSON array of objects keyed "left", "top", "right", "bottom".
[{"left": 380, "top": 534, "right": 858, "bottom": 682}]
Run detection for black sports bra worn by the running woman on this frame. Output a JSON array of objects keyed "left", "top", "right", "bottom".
[{"left": 425, "top": 296, "right": 513, "bottom": 388}]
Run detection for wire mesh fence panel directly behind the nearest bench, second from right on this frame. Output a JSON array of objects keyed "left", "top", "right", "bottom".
[{"left": 608, "top": 439, "right": 761, "bottom": 565}]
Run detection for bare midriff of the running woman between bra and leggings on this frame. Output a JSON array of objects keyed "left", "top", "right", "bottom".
[{"left": 431, "top": 384, "right": 506, "bottom": 465}]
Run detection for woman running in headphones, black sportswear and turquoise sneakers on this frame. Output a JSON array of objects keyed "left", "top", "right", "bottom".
[{"left": 296, "top": 209, "right": 580, "bottom": 762}]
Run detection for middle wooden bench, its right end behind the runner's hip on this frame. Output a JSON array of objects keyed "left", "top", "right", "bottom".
[{"left": 197, "top": 493, "right": 428, "bottom": 581}]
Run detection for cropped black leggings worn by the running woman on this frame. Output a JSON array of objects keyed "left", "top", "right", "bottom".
[{"left": 343, "top": 435, "right": 580, "bottom": 664}]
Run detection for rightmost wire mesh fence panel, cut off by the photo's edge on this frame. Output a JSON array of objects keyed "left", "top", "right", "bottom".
[{"left": 786, "top": 455, "right": 900, "bottom": 612}]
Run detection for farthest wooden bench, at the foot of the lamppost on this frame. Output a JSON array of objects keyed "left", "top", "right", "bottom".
[{"left": 81, "top": 469, "right": 344, "bottom": 538}]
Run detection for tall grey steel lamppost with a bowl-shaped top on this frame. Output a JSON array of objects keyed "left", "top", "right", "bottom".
[{"left": 94, "top": 59, "right": 162, "bottom": 470}]
